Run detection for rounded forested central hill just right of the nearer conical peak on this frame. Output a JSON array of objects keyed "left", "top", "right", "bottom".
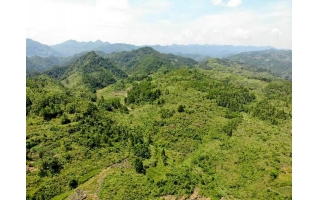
[{"left": 106, "top": 47, "right": 197, "bottom": 75}]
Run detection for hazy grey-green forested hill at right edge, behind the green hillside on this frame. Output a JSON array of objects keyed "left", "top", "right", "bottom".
[{"left": 226, "top": 49, "right": 292, "bottom": 80}]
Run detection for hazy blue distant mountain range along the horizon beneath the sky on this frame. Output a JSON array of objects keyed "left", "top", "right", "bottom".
[{"left": 27, "top": 39, "right": 274, "bottom": 58}]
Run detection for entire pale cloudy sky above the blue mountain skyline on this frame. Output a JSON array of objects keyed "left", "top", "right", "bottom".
[{"left": 26, "top": 0, "right": 292, "bottom": 49}]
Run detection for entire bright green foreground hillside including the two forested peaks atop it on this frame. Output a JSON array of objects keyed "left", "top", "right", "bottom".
[{"left": 26, "top": 47, "right": 292, "bottom": 200}]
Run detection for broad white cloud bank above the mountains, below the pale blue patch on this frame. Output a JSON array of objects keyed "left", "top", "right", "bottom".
[{"left": 27, "top": 0, "right": 292, "bottom": 48}]
